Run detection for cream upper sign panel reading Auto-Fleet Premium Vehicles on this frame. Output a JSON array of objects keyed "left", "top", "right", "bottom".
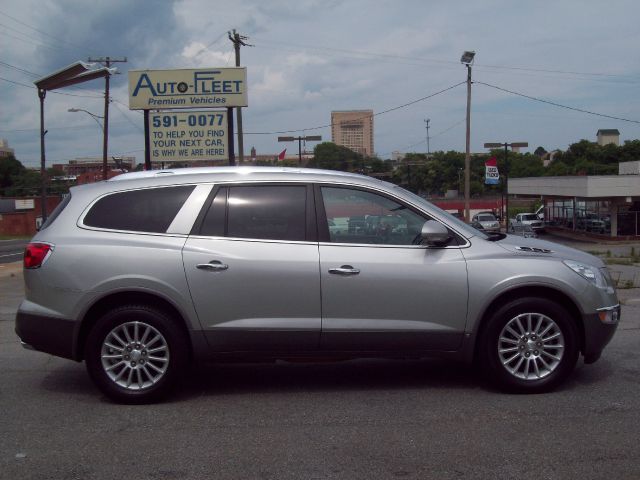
[{"left": 129, "top": 67, "right": 248, "bottom": 110}]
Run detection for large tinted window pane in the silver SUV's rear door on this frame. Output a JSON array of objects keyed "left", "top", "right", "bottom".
[{"left": 227, "top": 185, "right": 307, "bottom": 240}]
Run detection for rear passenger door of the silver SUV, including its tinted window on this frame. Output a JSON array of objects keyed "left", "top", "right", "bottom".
[{"left": 183, "top": 184, "right": 321, "bottom": 351}]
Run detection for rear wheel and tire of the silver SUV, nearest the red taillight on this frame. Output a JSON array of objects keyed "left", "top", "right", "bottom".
[{"left": 84, "top": 305, "right": 189, "bottom": 404}]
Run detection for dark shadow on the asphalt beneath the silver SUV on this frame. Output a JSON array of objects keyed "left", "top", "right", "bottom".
[{"left": 40, "top": 359, "right": 614, "bottom": 403}]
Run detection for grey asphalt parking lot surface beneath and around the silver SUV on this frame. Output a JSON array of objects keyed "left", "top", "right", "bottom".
[{"left": 0, "top": 248, "right": 640, "bottom": 479}]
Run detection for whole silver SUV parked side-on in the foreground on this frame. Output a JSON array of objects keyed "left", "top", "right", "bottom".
[{"left": 16, "top": 167, "right": 620, "bottom": 403}]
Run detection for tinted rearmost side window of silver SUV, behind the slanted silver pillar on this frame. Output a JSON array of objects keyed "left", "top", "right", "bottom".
[{"left": 84, "top": 185, "right": 195, "bottom": 233}]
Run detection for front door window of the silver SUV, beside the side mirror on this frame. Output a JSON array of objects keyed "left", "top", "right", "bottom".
[{"left": 322, "top": 187, "right": 427, "bottom": 245}]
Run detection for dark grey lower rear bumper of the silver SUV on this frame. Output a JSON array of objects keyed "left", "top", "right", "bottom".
[{"left": 16, "top": 311, "right": 76, "bottom": 359}]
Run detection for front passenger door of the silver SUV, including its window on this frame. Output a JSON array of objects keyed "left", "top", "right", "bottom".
[{"left": 319, "top": 187, "right": 468, "bottom": 352}]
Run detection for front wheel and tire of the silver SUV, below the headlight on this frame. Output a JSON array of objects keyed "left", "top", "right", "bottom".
[{"left": 479, "top": 297, "right": 580, "bottom": 393}]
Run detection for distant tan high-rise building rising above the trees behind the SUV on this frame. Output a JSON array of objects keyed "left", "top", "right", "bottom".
[{"left": 331, "top": 110, "right": 374, "bottom": 157}]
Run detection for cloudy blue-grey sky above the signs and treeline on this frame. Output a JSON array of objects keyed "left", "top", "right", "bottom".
[{"left": 0, "top": 0, "right": 640, "bottom": 167}]
